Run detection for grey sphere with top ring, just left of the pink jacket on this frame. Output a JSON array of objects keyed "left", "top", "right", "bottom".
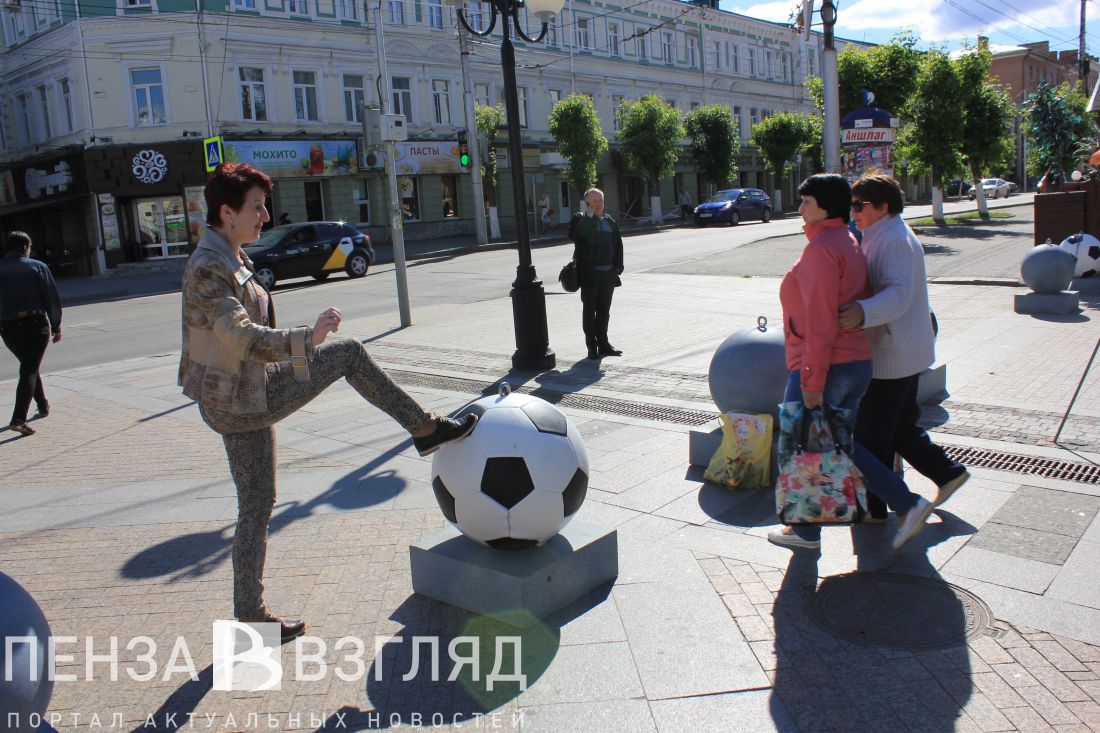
[{"left": 710, "top": 316, "right": 787, "bottom": 417}]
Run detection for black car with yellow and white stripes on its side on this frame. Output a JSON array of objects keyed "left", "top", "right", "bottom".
[{"left": 244, "top": 221, "right": 374, "bottom": 289}]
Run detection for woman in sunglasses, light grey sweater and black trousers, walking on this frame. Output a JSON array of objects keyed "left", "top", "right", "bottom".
[{"left": 840, "top": 173, "right": 970, "bottom": 521}]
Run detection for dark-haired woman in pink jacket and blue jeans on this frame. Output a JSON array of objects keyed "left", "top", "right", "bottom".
[{"left": 768, "top": 174, "right": 932, "bottom": 549}]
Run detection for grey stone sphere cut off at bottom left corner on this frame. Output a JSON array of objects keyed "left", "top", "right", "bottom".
[{"left": 0, "top": 572, "right": 54, "bottom": 733}]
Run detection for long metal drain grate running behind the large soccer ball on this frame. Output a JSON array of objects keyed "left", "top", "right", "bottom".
[{"left": 388, "top": 370, "right": 716, "bottom": 425}]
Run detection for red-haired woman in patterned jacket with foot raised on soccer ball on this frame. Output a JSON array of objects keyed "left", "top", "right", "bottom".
[{"left": 179, "top": 163, "right": 476, "bottom": 641}]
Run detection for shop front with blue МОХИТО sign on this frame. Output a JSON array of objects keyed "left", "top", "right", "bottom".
[{"left": 222, "top": 139, "right": 358, "bottom": 226}]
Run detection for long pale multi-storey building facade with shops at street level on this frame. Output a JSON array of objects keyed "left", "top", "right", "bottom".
[{"left": 0, "top": 0, "right": 821, "bottom": 274}]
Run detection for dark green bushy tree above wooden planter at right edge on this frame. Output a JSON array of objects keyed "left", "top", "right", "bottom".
[{"left": 1024, "top": 83, "right": 1095, "bottom": 185}]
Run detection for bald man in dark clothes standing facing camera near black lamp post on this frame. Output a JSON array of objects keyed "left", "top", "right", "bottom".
[{"left": 569, "top": 188, "right": 623, "bottom": 359}]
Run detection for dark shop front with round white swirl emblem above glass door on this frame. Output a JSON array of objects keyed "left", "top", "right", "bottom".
[{"left": 85, "top": 140, "right": 206, "bottom": 267}]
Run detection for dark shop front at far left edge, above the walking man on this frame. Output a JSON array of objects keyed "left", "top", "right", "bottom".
[{"left": 0, "top": 147, "right": 98, "bottom": 275}]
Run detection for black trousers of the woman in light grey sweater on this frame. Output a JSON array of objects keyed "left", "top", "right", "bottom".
[{"left": 856, "top": 374, "right": 964, "bottom": 516}]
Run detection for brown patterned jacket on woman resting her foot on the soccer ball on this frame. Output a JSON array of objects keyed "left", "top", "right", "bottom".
[{"left": 178, "top": 229, "right": 312, "bottom": 414}]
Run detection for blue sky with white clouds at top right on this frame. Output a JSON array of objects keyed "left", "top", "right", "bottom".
[{"left": 722, "top": 0, "right": 1100, "bottom": 56}]
